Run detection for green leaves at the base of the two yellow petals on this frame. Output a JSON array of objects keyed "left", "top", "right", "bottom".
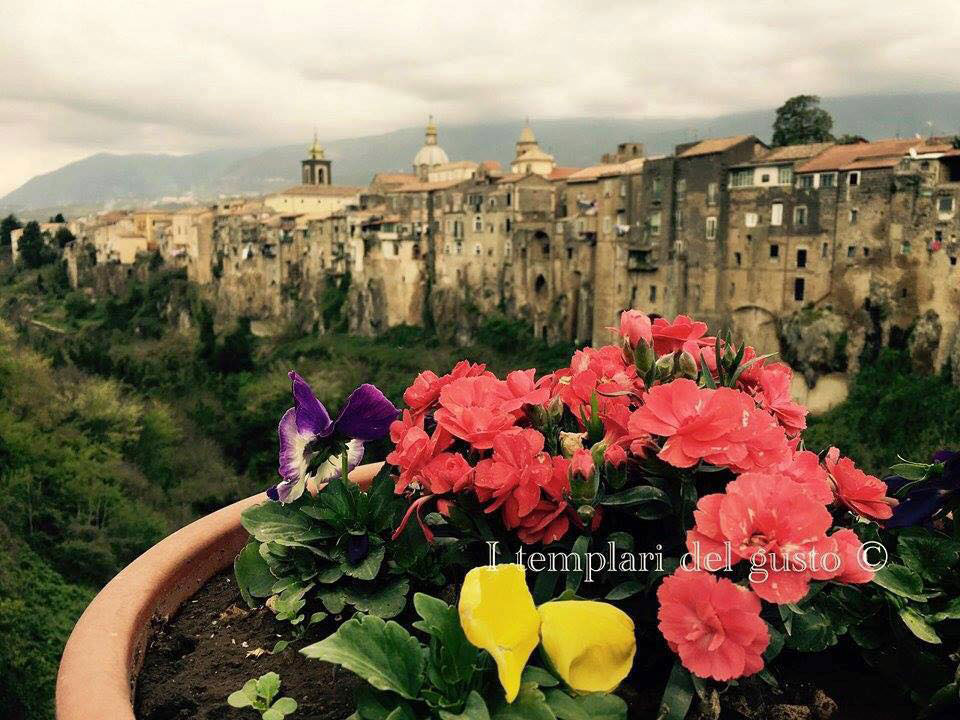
[{"left": 300, "top": 593, "right": 627, "bottom": 720}]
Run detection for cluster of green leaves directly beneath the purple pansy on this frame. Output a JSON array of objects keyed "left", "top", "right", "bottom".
[{"left": 234, "top": 470, "right": 443, "bottom": 625}]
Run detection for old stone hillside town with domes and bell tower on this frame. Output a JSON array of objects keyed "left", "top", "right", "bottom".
[{"left": 12, "top": 118, "right": 960, "bottom": 388}]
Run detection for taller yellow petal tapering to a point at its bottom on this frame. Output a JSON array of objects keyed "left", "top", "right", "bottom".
[{"left": 460, "top": 565, "right": 540, "bottom": 702}]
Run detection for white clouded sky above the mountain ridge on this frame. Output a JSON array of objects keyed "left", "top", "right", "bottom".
[{"left": 0, "top": 0, "right": 960, "bottom": 195}]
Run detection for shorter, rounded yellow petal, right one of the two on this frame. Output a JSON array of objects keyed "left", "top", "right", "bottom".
[{"left": 540, "top": 600, "right": 637, "bottom": 693}]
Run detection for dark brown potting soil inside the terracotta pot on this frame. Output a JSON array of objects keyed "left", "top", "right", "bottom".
[{"left": 135, "top": 570, "right": 917, "bottom": 720}]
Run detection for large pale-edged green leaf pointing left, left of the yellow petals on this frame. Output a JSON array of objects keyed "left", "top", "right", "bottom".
[{"left": 300, "top": 615, "right": 426, "bottom": 700}]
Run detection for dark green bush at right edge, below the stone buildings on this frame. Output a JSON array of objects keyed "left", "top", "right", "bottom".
[{"left": 804, "top": 349, "right": 960, "bottom": 476}]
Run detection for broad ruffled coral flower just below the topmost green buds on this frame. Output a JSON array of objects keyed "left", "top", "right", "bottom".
[{"left": 628, "top": 379, "right": 746, "bottom": 467}]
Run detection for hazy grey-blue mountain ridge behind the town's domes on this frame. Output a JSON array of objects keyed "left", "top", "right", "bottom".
[{"left": 7, "top": 93, "right": 960, "bottom": 212}]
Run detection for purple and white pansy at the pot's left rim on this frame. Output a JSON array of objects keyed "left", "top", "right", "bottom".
[{"left": 267, "top": 372, "right": 399, "bottom": 503}]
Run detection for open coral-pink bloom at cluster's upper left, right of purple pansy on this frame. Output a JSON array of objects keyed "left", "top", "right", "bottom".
[{"left": 434, "top": 376, "right": 516, "bottom": 450}]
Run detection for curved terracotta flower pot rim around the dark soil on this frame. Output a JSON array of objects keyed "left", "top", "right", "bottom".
[{"left": 56, "top": 463, "right": 383, "bottom": 720}]
